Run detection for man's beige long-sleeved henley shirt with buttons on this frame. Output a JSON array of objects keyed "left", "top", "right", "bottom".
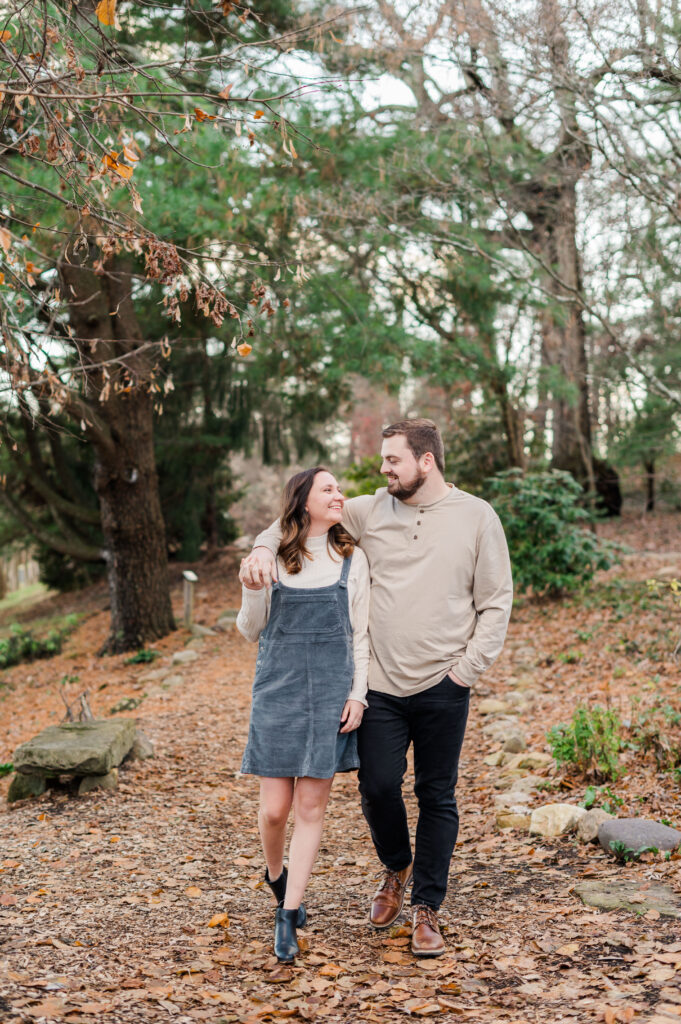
[{"left": 255, "top": 486, "right": 513, "bottom": 699}]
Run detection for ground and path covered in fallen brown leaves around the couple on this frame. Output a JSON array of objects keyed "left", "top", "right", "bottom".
[{"left": 0, "top": 516, "right": 681, "bottom": 1024}]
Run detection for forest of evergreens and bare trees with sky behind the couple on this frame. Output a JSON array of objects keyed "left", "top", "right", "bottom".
[{"left": 0, "top": 0, "right": 681, "bottom": 651}]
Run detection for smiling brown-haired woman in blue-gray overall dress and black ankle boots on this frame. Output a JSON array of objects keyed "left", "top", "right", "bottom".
[{"left": 237, "top": 466, "right": 370, "bottom": 963}]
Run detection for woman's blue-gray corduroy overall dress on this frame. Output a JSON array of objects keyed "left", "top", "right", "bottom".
[{"left": 241, "top": 557, "right": 359, "bottom": 778}]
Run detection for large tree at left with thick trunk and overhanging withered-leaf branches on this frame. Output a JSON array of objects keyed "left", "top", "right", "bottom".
[{"left": 0, "top": 0, "right": 313, "bottom": 651}]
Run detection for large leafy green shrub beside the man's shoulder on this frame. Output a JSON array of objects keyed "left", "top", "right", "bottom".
[{"left": 488, "top": 469, "right": 614, "bottom": 597}]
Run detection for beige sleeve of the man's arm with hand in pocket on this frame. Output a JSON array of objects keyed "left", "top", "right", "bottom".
[{"left": 452, "top": 516, "right": 513, "bottom": 686}]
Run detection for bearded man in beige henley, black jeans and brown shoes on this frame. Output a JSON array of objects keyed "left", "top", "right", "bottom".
[{"left": 240, "top": 420, "right": 513, "bottom": 956}]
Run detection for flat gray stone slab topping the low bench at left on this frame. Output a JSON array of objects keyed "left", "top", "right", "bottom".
[{"left": 13, "top": 718, "right": 136, "bottom": 775}]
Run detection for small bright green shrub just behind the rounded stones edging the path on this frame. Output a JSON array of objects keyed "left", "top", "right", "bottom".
[{"left": 546, "top": 705, "right": 622, "bottom": 779}]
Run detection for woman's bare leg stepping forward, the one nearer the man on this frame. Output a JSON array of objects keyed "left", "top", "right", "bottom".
[{"left": 284, "top": 777, "right": 334, "bottom": 910}]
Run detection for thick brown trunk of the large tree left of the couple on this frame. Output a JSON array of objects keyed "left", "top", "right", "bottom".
[{"left": 59, "top": 231, "right": 175, "bottom": 653}]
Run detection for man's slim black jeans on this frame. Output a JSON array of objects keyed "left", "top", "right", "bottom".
[{"left": 357, "top": 676, "right": 470, "bottom": 910}]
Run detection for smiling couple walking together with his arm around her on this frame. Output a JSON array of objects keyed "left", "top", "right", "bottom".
[{"left": 237, "top": 420, "right": 513, "bottom": 962}]
